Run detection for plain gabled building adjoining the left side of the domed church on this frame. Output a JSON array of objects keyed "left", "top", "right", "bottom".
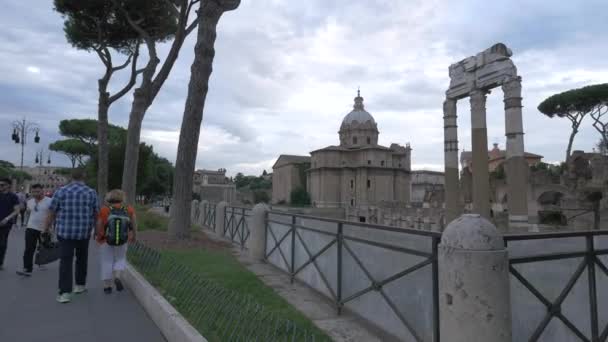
[{"left": 270, "top": 154, "right": 310, "bottom": 204}]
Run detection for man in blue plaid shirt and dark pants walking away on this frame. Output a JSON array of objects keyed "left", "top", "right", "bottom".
[{"left": 46, "top": 169, "right": 99, "bottom": 303}]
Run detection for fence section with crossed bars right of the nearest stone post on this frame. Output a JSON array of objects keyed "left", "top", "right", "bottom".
[{"left": 505, "top": 230, "right": 608, "bottom": 342}]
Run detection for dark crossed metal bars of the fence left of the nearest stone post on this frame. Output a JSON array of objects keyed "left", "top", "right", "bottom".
[{"left": 265, "top": 212, "right": 441, "bottom": 342}]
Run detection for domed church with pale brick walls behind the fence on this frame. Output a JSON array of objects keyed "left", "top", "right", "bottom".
[{"left": 306, "top": 93, "right": 411, "bottom": 221}]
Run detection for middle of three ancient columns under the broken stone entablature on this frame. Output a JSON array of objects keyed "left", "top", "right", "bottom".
[{"left": 470, "top": 90, "right": 490, "bottom": 219}]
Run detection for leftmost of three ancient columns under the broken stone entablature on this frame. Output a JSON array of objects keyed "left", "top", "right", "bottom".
[{"left": 443, "top": 98, "right": 461, "bottom": 223}]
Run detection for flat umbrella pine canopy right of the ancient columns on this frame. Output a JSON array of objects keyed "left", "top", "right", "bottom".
[{"left": 538, "top": 83, "right": 608, "bottom": 117}]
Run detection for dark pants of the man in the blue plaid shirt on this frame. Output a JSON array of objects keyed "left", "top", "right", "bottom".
[{"left": 59, "top": 238, "right": 89, "bottom": 294}]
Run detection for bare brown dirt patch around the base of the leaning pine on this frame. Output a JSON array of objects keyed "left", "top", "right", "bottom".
[{"left": 137, "top": 230, "right": 232, "bottom": 250}]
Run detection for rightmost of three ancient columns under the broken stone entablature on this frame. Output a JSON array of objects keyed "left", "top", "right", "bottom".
[{"left": 502, "top": 77, "right": 528, "bottom": 227}]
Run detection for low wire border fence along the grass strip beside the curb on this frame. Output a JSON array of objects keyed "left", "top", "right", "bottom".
[{"left": 128, "top": 243, "right": 330, "bottom": 341}]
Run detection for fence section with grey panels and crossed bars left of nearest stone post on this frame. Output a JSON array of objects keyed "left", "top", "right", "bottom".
[{"left": 266, "top": 212, "right": 441, "bottom": 341}]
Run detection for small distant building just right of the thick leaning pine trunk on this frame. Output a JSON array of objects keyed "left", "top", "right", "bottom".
[{"left": 192, "top": 169, "right": 236, "bottom": 203}]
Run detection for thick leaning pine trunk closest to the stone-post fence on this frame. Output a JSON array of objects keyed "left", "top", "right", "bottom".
[{"left": 168, "top": 1, "right": 239, "bottom": 239}]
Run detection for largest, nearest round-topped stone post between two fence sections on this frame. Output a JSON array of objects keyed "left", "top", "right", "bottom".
[{"left": 438, "top": 214, "right": 512, "bottom": 342}]
